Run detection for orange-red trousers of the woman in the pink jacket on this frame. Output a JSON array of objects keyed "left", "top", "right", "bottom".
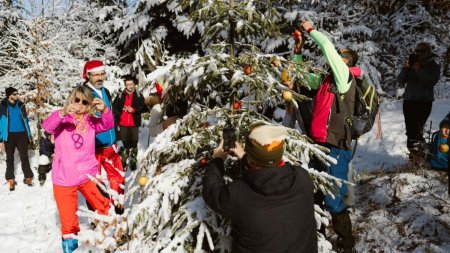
[{"left": 53, "top": 180, "right": 109, "bottom": 236}]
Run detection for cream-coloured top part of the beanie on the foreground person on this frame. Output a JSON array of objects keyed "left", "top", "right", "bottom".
[{"left": 248, "top": 125, "right": 287, "bottom": 146}]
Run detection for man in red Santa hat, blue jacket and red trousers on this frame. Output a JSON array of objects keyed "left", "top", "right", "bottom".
[{"left": 83, "top": 60, "right": 125, "bottom": 214}]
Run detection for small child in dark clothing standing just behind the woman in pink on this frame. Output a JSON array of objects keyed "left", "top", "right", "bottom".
[{"left": 38, "top": 132, "right": 55, "bottom": 185}]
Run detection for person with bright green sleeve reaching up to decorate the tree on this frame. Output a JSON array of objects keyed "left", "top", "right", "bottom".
[{"left": 301, "top": 21, "right": 361, "bottom": 253}]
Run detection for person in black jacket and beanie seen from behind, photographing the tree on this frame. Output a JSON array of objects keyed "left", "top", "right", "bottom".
[{"left": 202, "top": 124, "right": 318, "bottom": 253}]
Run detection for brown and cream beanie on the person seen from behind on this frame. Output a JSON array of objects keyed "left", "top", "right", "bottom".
[{"left": 245, "top": 125, "right": 287, "bottom": 168}]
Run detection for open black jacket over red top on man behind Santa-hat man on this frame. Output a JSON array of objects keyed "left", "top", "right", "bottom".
[{"left": 112, "top": 91, "right": 149, "bottom": 127}]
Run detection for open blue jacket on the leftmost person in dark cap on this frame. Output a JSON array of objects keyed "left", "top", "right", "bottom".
[{"left": 0, "top": 98, "right": 31, "bottom": 142}]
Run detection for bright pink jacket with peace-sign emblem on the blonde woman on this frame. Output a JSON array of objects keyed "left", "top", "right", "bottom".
[{"left": 42, "top": 109, "right": 114, "bottom": 186}]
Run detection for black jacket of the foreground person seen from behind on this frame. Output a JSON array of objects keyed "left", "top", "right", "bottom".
[{"left": 203, "top": 158, "right": 318, "bottom": 253}]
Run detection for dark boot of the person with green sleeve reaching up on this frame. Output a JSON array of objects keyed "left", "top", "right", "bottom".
[{"left": 331, "top": 209, "right": 355, "bottom": 253}]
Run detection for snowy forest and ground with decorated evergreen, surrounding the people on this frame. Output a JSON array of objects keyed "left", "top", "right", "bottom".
[{"left": 0, "top": 0, "right": 450, "bottom": 252}]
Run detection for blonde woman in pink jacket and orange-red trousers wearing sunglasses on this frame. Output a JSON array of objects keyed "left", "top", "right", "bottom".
[{"left": 42, "top": 86, "right": 114, "bottom": 252}]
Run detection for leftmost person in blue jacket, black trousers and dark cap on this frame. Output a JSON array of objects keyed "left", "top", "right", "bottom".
[{"left": 0, "top": 87, "right": 34, "bottom": 191}]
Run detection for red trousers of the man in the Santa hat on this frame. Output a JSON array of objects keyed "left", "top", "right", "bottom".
[{"left": 95, "top": 146, "right": 125, "bottom": 194}]
